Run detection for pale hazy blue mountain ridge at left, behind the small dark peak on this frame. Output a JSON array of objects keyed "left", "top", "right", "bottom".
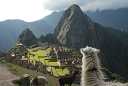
[{"left": 0, "top": 20, "right": 53, "bottom": 51}]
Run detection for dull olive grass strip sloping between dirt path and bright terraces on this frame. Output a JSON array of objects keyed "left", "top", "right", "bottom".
[{"left": 6, "top": 63, "right": 59, "bottom": 86}]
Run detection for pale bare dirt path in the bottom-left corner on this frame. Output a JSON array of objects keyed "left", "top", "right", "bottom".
[{"left": 0, "top": 64, "right": 18, "bottom": 86}]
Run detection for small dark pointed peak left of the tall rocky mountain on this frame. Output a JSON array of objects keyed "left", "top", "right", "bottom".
[{"left": 18, "top": 29, "right": 37, "bottom": 47}]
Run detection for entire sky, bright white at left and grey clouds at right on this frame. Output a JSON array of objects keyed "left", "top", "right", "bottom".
[{"left": 0, "top": 0, "right": 128, "bottom": 22}]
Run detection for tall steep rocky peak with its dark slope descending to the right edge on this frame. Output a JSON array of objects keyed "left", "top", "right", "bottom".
[{"left": 54, "top": 5, "right": 128, "bottom": 78}]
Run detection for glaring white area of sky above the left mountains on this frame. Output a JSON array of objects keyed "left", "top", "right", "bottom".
[{"left": 0, "top": 0, "right": 50, "bottom": 21}]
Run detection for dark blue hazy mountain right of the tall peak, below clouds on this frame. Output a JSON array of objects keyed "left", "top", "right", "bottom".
[{"left": 87, "top": 8, "right": 128, "bottom": 31}]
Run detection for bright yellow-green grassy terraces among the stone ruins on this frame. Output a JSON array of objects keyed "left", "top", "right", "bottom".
[{"left": 27, "top": 48, "right": 69, "bottom": 77}]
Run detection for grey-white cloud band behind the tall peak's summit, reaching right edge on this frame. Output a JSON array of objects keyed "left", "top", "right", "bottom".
[{"left": 43, "top": 0, "right": 128, "bottom": 10}]
